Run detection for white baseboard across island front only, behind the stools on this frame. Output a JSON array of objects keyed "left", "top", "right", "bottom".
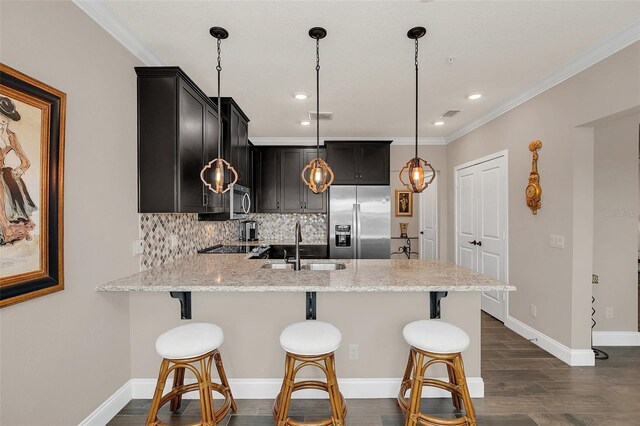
[{"left": 131, "top": 377, "right": 484, "bottom": 399}]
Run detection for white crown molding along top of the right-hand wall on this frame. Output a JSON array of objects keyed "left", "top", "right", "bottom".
[{"left": 445, "top": 21, "right": 640, "bottom": 144}]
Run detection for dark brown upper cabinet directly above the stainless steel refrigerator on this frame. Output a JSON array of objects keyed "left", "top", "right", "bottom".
[{"left": 325, "top": 141, "right": 392, "bottom": 185}]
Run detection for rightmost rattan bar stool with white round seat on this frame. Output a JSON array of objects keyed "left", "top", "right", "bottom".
[{"left": 398, "top": 320, "right": 477, "bottom": 426}]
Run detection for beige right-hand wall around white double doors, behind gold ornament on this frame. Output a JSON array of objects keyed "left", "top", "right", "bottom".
[{"left": 447, "top": 43, "right": 640, "bottom": 349}]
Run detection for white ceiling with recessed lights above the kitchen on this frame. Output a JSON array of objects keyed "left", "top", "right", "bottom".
[{"left": 77, "top": 0, "right": 640, "bottom": 141}]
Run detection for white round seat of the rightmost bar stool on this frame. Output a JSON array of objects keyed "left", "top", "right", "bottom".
[{"left": 402, "top": 320, "right": 469, "bottom": 354}]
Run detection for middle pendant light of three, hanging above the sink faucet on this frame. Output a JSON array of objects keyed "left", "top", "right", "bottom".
[{"left": 301, "top": 27, "right": 333, "bottom": 194}]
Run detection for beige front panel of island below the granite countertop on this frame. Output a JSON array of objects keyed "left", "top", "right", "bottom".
[{"left": 130, "top": 292, "right": 480, "bottom": 379}]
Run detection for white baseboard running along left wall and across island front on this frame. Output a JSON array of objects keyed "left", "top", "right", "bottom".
[{"left": 80, "top": 377, "right": 484, "bottom": 426}]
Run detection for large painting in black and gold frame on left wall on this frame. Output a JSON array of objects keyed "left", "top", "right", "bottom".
[{"left": 0, "top": 63, "right": 66, "bottom": 307}]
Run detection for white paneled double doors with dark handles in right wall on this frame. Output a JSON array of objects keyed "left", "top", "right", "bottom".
[{"left": 456, "top": 156, "right": 507, "bottom": 321}]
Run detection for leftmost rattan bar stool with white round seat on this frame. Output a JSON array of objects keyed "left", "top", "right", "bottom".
[{"left": 147, "top": 323, "right": 237, "bottom": 426}]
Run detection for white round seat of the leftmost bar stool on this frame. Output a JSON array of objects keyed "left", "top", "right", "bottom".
[{"left": 156, "top": 323, "right": 224, "bottom": 359}]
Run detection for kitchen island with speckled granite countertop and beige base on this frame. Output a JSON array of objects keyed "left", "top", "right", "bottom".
[{"left": 97, "top": 254, "right": 515, "bottom": 398}]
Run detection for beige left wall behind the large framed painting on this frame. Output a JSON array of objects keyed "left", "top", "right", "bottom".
[{"left": 0, "top": 1, "right": 139, "bottom": 425}]
